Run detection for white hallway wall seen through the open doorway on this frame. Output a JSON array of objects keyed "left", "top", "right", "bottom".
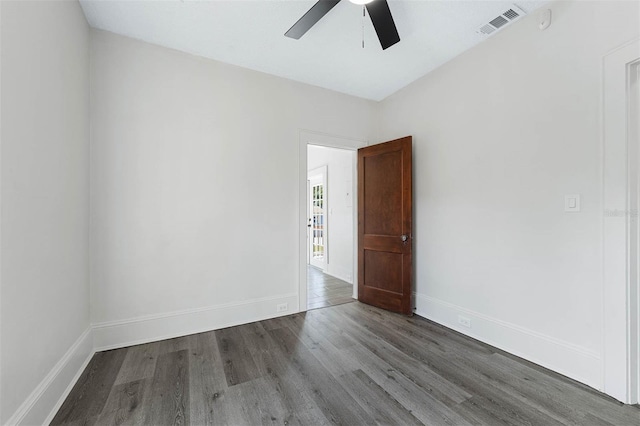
[{"left": 307, "top": 145, "right": 358, "bottom": 284}]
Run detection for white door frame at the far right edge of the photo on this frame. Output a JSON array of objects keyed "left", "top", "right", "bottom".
[{"left": 602, "top": 36, "right": 640, "bottom": 404}]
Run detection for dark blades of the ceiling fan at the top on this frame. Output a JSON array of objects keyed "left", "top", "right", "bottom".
[{"left": 284, "top": 0, "right": 400, "bottom": 50}]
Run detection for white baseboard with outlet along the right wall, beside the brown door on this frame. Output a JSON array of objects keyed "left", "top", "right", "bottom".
[{"left": 415, "top": 294, "right": 603, "bottom": 391}]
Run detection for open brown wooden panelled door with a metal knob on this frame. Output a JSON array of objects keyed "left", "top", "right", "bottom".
[{"left": 358, "top": 136, "right": 413, "bottom": 315}]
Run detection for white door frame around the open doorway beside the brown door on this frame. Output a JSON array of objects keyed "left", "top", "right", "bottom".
[{"left": 298, "top": 130, "right": 368, "bottom": 312}]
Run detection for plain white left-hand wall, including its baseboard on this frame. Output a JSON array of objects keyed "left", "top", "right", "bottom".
[{"left": 0, "top": 1, "right": 90, "bottom": 424}]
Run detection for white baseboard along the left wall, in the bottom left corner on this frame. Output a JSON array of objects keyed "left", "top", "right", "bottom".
[{"left": 6, "top": 327, "right": 94, "bottom": 425}]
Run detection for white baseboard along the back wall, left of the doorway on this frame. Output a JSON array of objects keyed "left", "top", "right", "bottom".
[{"left": 93, "top": 293, "right": 299, "bottom": 352}]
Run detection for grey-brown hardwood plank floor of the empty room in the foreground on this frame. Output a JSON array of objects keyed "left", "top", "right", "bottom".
[{"left": 52, "top": 302, "right": 640, "bottom": 426}]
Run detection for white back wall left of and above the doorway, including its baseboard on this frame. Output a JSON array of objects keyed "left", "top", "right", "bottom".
[{"left": 91, "top": 31, "right": 375, "bottom": 347}]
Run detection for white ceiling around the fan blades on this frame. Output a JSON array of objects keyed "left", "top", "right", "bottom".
[{"left": 80, "top": 0, "right": 546, "bottom": 100}]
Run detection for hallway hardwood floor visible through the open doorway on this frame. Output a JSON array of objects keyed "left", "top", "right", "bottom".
[{"left": 307, "top": 266, "right": 355, "bottom": 309}]
